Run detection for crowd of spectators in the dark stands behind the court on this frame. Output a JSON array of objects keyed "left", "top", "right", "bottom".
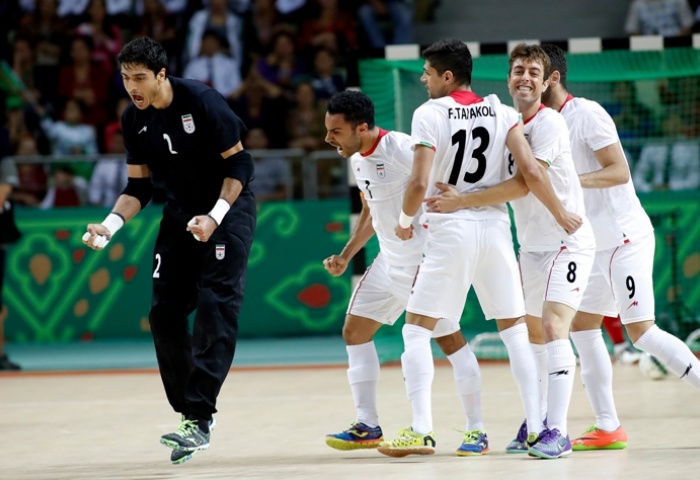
[{"left": 0, "top": 0, "right": 700, "bottom": 208}]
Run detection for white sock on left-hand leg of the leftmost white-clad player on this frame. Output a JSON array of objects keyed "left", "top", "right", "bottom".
[{"left": 345, "top": 341, "right": 379, "bottom": 427}]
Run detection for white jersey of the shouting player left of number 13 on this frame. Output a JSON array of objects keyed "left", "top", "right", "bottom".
[{"left": 350, "top": 129, "right": 426, "bottom": 266}]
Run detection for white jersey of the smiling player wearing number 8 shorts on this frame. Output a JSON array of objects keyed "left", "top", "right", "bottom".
[{"left": 506, "top": 105, "right": 595, "bottom": 252}]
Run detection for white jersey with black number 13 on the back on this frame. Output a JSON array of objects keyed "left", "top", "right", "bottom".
[{"left": 411, "top": 91, "right": 520, "bottom": 222}]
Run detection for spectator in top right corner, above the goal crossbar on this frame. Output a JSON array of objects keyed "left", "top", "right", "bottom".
[{"left": 625, "top": 0, "right": 693, "bottom": 37}]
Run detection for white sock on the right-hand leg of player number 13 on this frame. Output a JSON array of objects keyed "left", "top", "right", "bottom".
[{"left": 499, "top": 323, "right": 546, "bottom": 433}]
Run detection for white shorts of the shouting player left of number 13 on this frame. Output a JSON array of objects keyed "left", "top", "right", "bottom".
[{"left": 347, "top": 252, "right": 459, "bottom": 338}]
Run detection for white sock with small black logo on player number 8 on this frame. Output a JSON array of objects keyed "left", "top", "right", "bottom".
[{"left": 547, "top": 338, "right": 576, "bottom": 436}]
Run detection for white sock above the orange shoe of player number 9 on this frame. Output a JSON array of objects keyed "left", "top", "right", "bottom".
[{"left": 571, "top": 328, "right": 620, "bottom": 432}]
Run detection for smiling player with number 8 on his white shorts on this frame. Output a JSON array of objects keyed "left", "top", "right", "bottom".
[{"left": 426, "top": 44, "right": 595, "bottom": 458}]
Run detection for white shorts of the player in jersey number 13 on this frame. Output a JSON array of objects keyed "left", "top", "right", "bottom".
[{"left": 406, "top": 218, "right": 525, "bottom": 324}]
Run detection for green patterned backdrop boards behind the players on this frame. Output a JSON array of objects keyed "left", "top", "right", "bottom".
[{"left": 4, "top": 192, "right": 700, "bottom": 346}]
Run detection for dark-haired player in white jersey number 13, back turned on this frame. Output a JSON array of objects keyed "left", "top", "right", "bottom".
[{"left": 378, "top": 39, "right": 581, "bottom": 457}]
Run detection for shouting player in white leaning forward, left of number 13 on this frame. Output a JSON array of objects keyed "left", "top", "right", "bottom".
[{"left": 323, "top": 91, "right": 488, "bottom": 456}]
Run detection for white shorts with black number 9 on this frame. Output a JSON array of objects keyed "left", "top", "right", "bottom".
[{"left": 579, "top": 233, "right": 656, "bottom": 323}]
